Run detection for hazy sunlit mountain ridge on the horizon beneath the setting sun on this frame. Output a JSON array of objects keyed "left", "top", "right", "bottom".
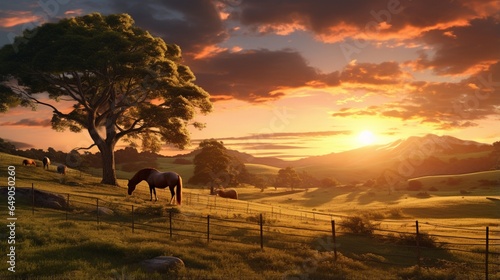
[{"left": 174, "top": 134, "right": 494, "bottom": 183}]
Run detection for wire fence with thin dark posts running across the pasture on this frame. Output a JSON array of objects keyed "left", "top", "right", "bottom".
[{"left": 23, "top": 185, "right": 500, "bottom": 279}]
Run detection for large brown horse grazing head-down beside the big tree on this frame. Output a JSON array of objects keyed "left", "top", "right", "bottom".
[{"left": 127, "top": 168, "right": 182, "bottom": 205}]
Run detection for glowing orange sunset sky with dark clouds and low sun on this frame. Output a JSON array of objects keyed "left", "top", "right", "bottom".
[{"left": 0, "top": 0, "right": 500, "bottom": 160}]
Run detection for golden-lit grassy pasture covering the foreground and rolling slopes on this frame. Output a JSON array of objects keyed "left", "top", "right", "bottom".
[{"left": 0, "top": 154, "right": 500, "bottom": 279}]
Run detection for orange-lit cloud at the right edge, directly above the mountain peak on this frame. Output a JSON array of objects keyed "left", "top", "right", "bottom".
[{"left": 332, "top": 63, "right": 500, "bottom": 130}]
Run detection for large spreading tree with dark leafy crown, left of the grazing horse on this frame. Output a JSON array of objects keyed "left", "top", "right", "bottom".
[{"left": 0, "top": 13, "right": 212, "bottom": 185}]
